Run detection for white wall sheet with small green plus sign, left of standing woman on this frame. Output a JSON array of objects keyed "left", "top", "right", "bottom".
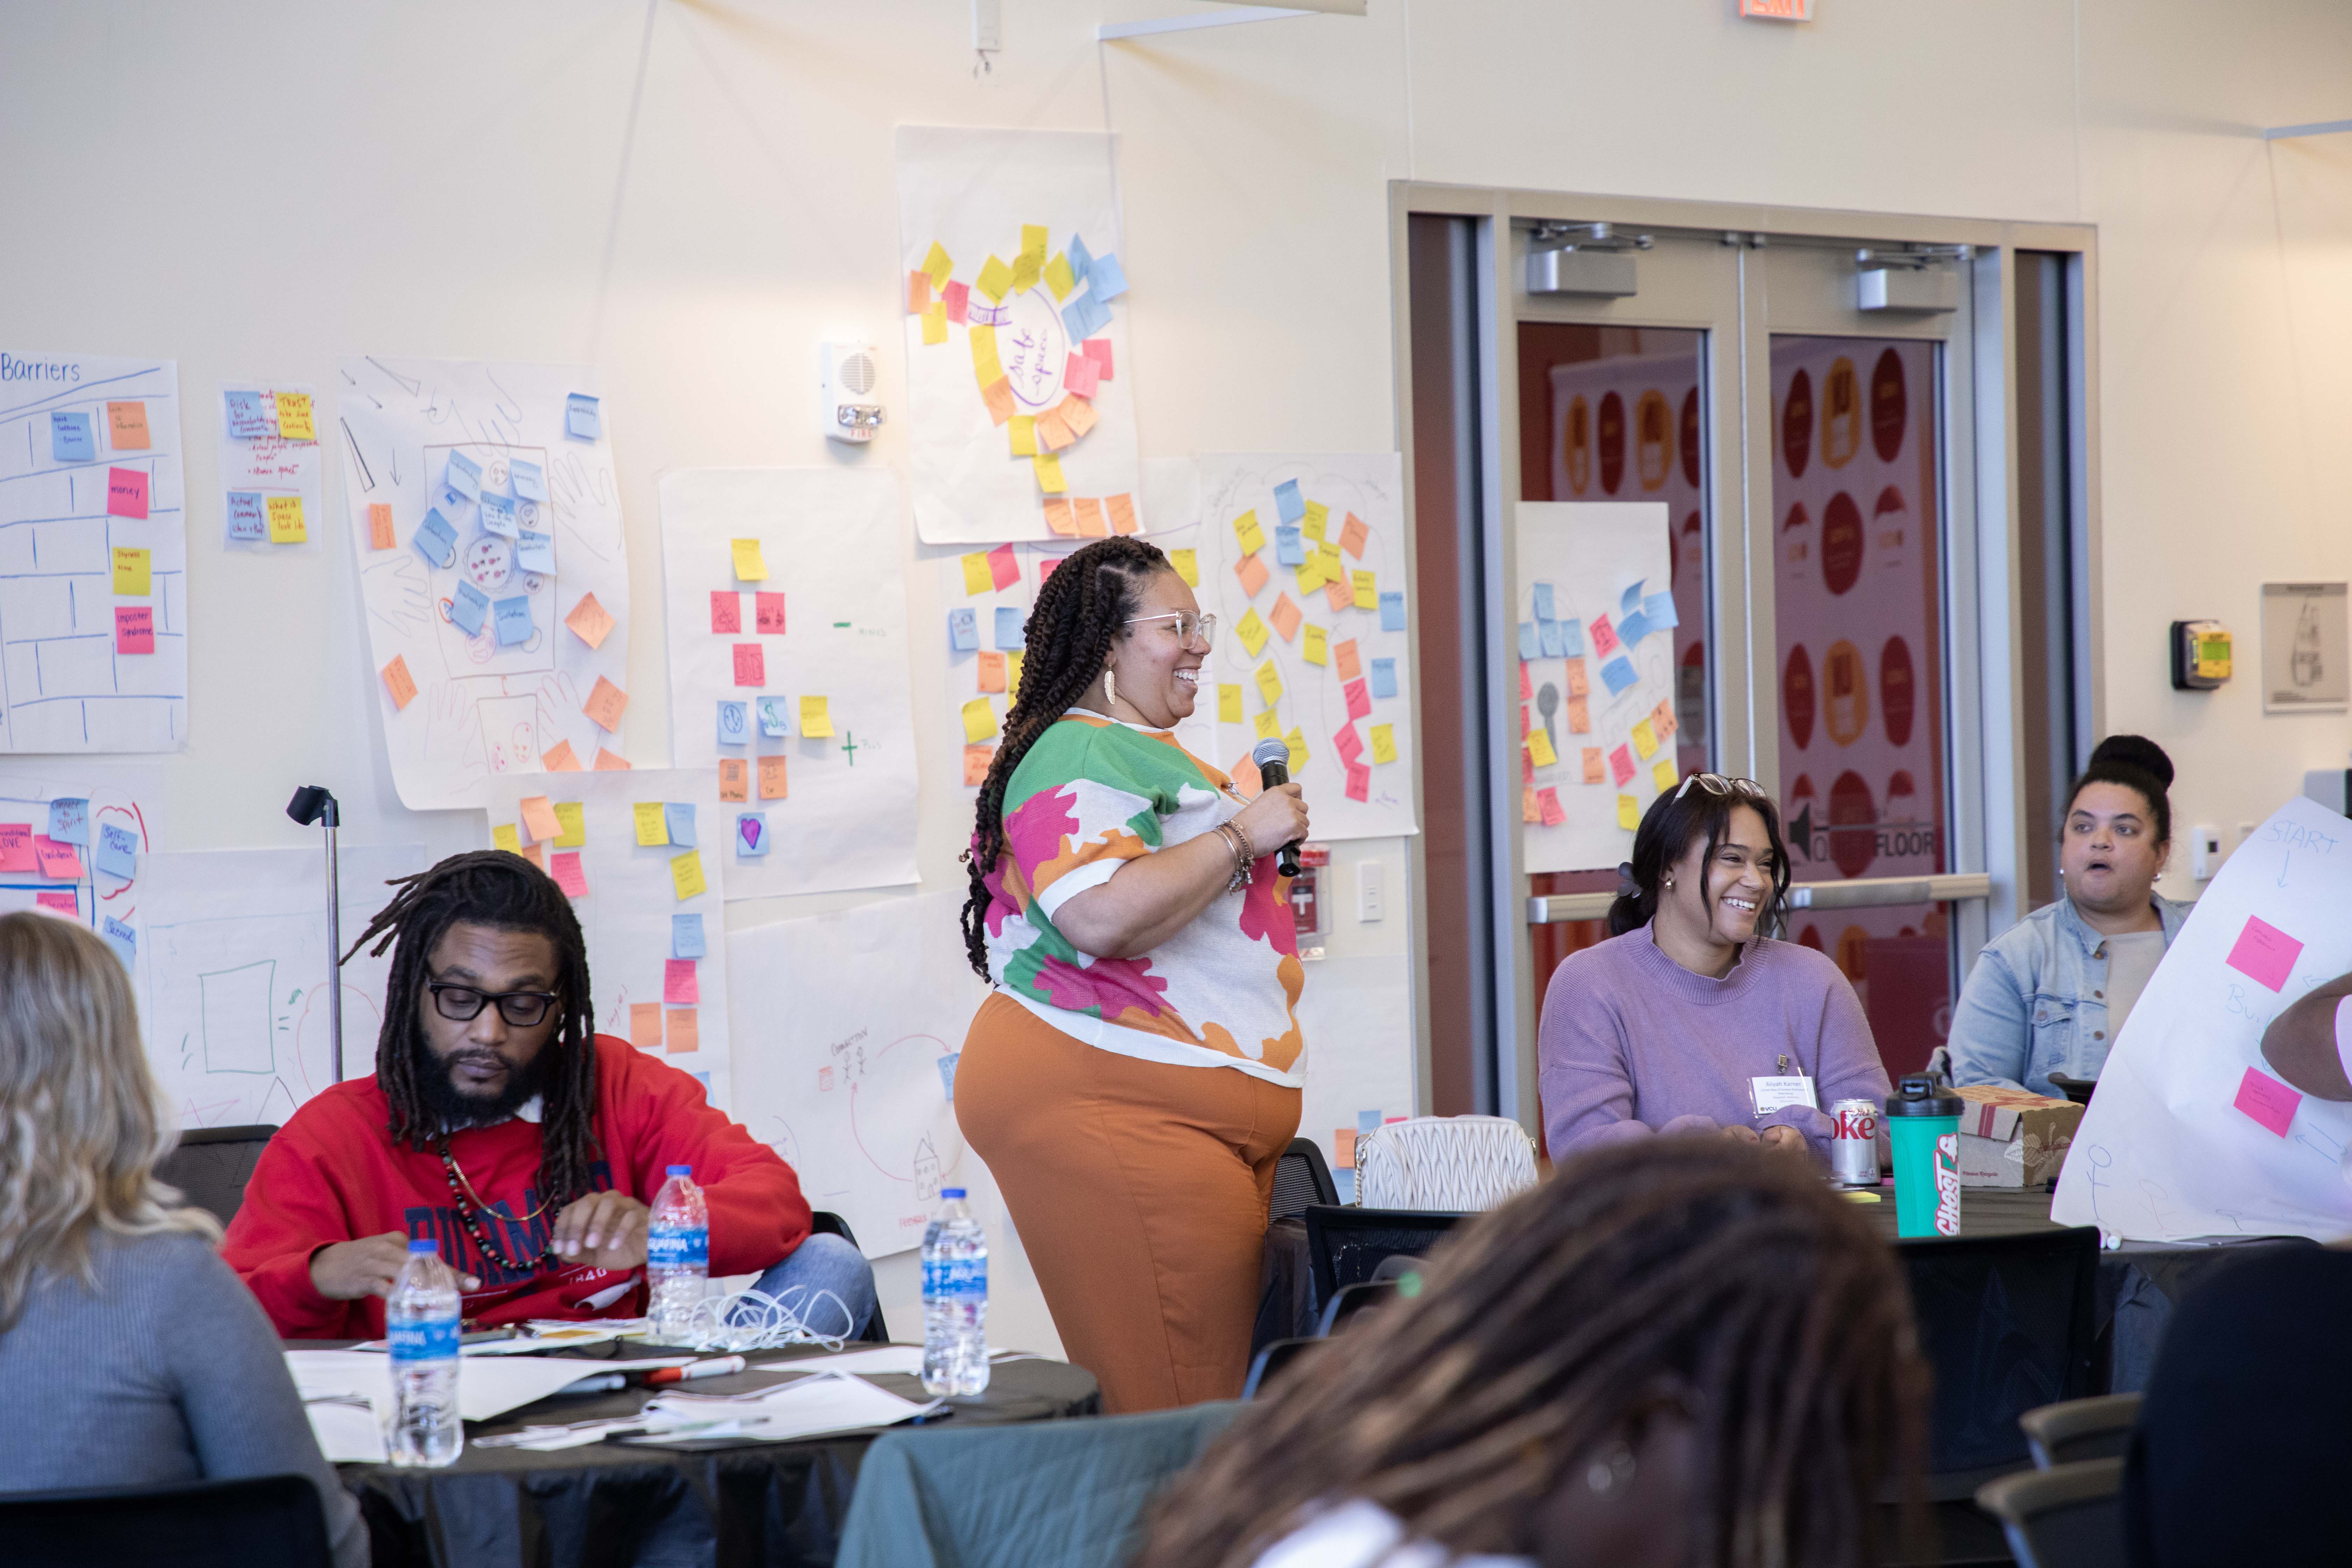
[{"left": 661, "top": 468, "right": 917, "bottom": 898}]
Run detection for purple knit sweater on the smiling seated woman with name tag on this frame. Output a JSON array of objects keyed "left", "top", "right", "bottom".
[{"left": 1536, "top": 926, "right": 1886, "bottom": 1161}]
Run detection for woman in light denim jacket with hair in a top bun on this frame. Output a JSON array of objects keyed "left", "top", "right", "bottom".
[{"left": 1950, "top": 736, "right": 2190, "bottom": 1096}]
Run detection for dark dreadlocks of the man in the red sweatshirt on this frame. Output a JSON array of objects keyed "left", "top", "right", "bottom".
[{"left": 343, "top": 849, "right": 595, "bottom": 1208}]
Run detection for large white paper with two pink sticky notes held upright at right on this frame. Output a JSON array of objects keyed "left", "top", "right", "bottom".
[{"left": 2051, "top": 797, "right": 2352, "bottom": 1241}]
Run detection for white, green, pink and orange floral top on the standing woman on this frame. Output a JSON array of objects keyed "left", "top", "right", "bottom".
[{"left": 988, "top": 710, "right": 1306, "bottom": 1086}]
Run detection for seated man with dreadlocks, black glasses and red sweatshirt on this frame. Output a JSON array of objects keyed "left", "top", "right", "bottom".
[{"left": 221, "top": 851, "right": 875, "bottom": 1340}]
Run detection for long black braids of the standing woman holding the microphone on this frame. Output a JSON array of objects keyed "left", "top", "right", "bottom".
[{"left": 964, "top": 538, "right": 1174, "bottom": 980}]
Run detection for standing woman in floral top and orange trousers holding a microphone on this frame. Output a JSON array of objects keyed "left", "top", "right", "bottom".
[{"left": 955, "top": 538, "right": 1308, "bottom": 1413}]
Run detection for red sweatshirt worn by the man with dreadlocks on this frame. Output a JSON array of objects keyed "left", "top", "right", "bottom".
[{"left": 221, "top": 1034, "right": 809, "bottom": 1340}]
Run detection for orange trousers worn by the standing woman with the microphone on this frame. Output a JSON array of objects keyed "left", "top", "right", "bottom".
[{"left": 955, "top": 992, "right": 1298, "bottom": 1415}]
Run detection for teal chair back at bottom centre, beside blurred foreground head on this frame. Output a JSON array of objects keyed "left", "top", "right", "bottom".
[{"left": 828, "top": 1404, "right": 1242, "bottom": 1568}]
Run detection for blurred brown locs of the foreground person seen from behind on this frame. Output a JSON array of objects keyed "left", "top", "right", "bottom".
[{"left": 1141, "top": 1138, "right": 1928, "bottom": 1568}]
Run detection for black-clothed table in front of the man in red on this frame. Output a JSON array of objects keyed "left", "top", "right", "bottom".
[{"left": 334, "top": 1340, "right": 1101, "bottom": 1568}]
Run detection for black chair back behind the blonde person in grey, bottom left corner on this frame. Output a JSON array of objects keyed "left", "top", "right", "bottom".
[{"left": 0, "top": 1476, "right": 334, "bottom": 1568}]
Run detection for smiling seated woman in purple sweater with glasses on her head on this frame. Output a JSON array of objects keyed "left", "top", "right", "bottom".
[{"left": 1536, "top": 774, "right": 1886, "bottom": 1164}]
